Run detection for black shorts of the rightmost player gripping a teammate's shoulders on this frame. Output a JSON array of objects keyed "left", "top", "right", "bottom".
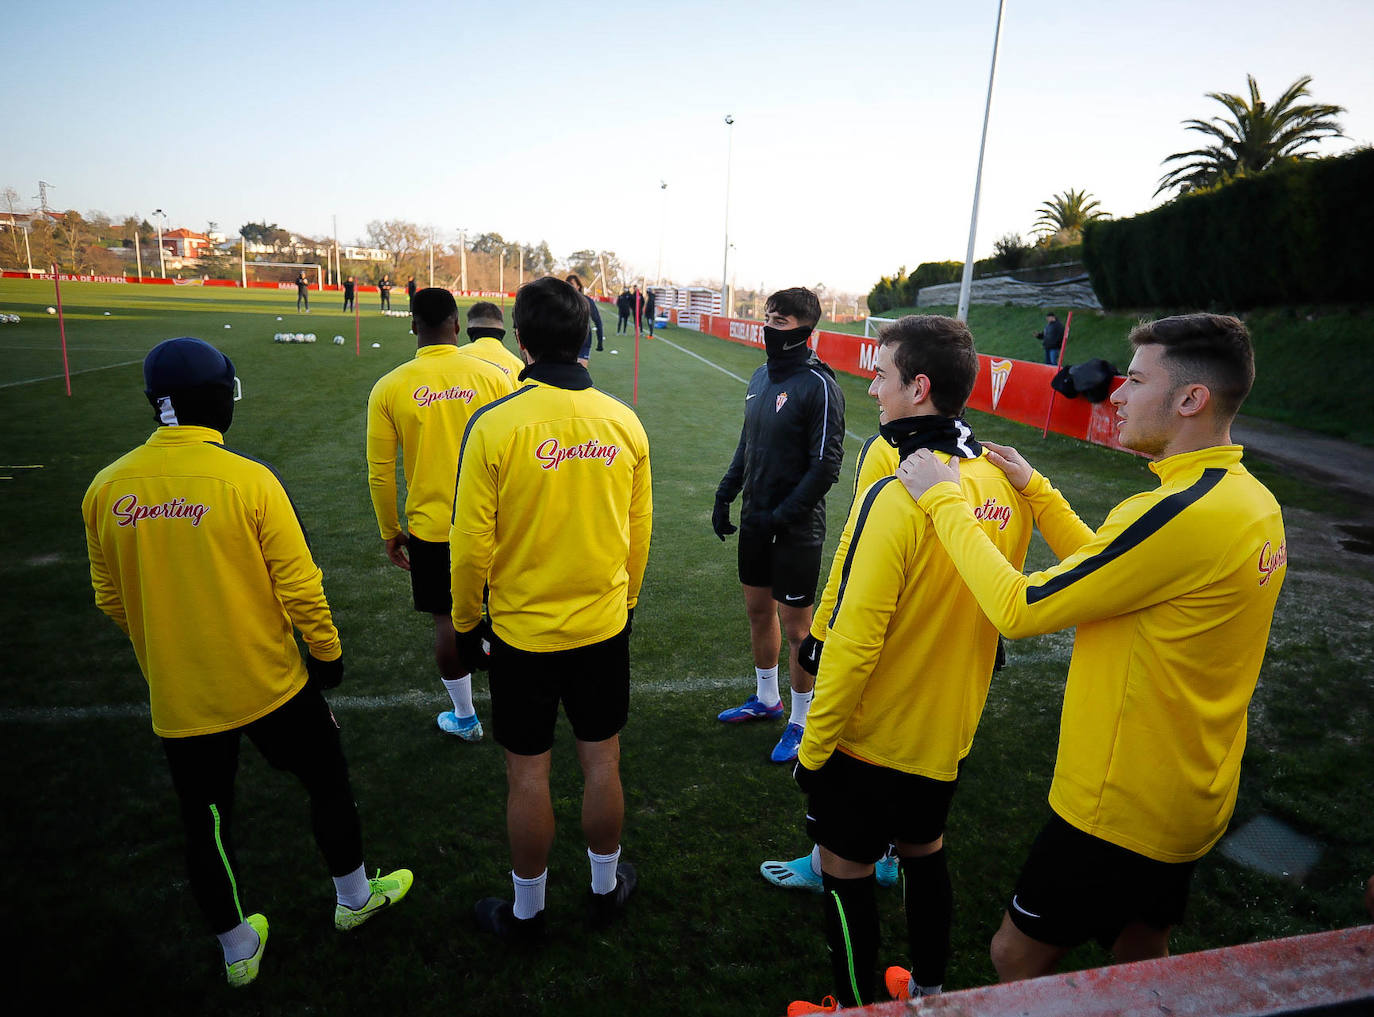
[{"left": 1007, "top": 815, "right": 1197, "bottom": 950}]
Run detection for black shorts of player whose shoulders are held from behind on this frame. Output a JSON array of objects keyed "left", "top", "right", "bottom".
[{"left": 807, "top": 750, "right": 959, "bottom": 864}]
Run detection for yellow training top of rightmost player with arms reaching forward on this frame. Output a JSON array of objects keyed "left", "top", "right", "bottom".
[{"left": 923, "top": 445, "right": 1287, "bottom": 862}]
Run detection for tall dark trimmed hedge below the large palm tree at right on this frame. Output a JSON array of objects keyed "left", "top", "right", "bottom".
[{"left": 1083, "top": 148, "right": 1374, "bottom": 309}]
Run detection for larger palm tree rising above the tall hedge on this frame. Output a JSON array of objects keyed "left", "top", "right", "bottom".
[{"left": 1154, "top": 74, "right": 1345, "bottom": 194}]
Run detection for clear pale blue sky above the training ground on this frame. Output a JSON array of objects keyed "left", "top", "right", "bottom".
[{"left": 0, "top": 0, "right": 1374, "bottom": 291}]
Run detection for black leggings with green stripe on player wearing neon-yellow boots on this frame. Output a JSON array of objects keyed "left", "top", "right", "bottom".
[{"left": 162, "top": 687, "right": 363, "bottom": 935}]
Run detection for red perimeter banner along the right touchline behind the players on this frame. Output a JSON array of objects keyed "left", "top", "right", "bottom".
[{"left": 699, "top": 315, "right": 1129, "bottom": 451}]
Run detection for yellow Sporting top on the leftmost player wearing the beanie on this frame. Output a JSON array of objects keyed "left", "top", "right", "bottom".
[{"left": 81, "top": 426, "right": 342, "bottom": 738}]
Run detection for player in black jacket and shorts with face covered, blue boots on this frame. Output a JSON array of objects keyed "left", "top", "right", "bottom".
[{"left": 710, "top": 287, "right": 845, "bottom": 763}]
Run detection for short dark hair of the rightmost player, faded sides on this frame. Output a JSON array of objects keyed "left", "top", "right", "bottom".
[{"left": 1129, "top": 315, "right": 1254, "bottom": 418}]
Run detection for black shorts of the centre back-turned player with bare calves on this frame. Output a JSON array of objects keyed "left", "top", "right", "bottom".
[{"left": 486, "top": 625, "right": 629, "bottom": 756}]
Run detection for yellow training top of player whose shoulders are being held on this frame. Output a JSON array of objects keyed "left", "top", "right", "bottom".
[{"left": 798, "top": 453, "right": 1033, "bottom": 781}]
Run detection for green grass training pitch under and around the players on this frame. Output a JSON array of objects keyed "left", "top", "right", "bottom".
[{"left": 0, "top": 280, "right": 1374, "bottom": 1014}]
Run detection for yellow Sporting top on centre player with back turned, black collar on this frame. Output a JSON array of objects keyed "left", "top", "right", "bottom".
[{"left": 449, "top": 364, "right": 653, "bottom": 653}]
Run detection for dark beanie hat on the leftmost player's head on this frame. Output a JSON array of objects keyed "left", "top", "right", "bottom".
[{"left": 143, "top": 335, "right": 234, "bottom": 432}]
